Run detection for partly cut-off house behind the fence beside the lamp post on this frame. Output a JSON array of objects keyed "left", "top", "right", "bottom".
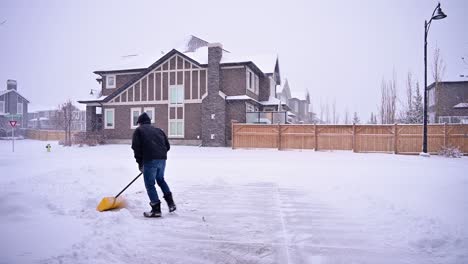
[{"left": 427, "top": 81, "right": 468, "bottom": 124}]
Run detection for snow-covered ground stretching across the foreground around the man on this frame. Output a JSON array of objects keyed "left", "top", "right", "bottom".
[{"left": 0, "top": 140, "right": 468, "bottom": 264}]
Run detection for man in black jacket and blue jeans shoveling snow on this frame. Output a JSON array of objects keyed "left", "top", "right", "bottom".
[{"left": 132, "top": 113, "right": 176, "bottom": 217}]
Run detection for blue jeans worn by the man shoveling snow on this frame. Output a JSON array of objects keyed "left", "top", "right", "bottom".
[{"left": 143, "top": 160, "right": 171, "bottom": 204}]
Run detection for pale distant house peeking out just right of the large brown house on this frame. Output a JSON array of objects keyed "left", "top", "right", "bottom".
[{"left": 278, "top": 79, "right": 314, "bottom": 124}]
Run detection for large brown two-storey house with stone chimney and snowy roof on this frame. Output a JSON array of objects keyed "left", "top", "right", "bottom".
[{"left": 79, "top": 36, "right": 281, "bottom": 146}]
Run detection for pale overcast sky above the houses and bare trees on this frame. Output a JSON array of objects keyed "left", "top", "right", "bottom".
[{"left": 0, "top": 0, "right": 468, "bottom": 121}]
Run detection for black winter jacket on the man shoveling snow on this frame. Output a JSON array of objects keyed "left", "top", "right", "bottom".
[{"left": 132, "top": 122, "right": 171, "bottom": 168}]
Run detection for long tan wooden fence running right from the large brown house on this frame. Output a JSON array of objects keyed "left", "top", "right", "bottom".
[{"left": 231, "top": 123, "right": 468, "bottom": 154}]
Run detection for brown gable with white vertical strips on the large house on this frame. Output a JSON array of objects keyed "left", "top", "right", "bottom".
[{"left": 104, "top": 50, "right": 208, "bottom": 104}]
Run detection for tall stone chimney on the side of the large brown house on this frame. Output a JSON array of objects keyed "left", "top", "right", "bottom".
[{"left": 202, "top": 43, "right": 226, "bottom": 147}]
